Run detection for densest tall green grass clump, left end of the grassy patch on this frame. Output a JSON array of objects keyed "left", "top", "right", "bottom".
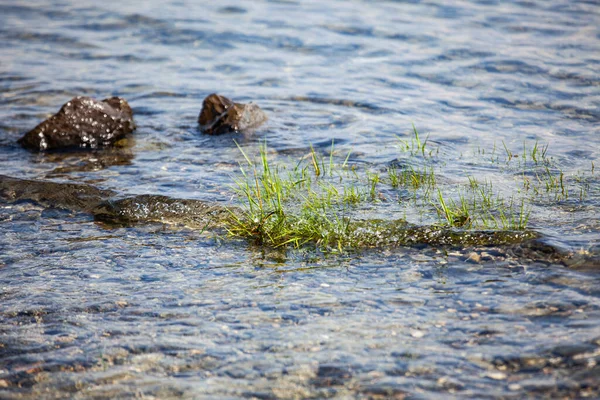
[{"left": 227, "top": 142, "right": 356, "bottom": 250}]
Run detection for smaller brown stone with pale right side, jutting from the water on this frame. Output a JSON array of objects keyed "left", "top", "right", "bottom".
[{"left": 198, "top": 93, "right": 267, "bottom": 135}]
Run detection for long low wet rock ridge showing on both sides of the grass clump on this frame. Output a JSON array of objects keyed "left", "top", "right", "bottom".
[{"left": 0, "top": 175, "right": 589, "bottom": 265}]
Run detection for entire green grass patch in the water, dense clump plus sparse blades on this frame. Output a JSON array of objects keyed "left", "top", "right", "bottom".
[{"left": 227, "top": 126, "right": 594, "bottom": 252}]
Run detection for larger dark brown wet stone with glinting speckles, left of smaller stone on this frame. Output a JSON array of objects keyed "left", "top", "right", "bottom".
[{"left": 19, "top": 96, "right": 135, "bottom": 151}]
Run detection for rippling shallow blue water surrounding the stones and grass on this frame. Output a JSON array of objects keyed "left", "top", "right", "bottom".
[{"left": 0, "top": 0, "right": 600, "bottom": 399}]
